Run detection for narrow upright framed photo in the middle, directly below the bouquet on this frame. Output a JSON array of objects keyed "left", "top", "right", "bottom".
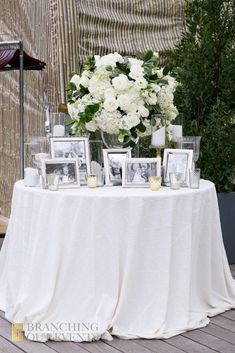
[{"left": 103, "top": 148, "right": 131, "bottom": 185}]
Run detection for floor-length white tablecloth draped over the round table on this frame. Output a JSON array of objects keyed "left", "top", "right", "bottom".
[{"left": 0, "top": 181, "right": 235, "bottom": 341}]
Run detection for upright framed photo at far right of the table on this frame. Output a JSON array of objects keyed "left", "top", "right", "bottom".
[{"left": 163, "top": 148, "right": 193, "bottom": 186}]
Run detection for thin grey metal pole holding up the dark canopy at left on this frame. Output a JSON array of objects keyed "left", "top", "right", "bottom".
[{"left": 19, "top": 41, "right": 24, "bottom": 179}]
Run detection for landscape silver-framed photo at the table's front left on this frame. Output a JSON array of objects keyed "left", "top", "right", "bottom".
[{"left": 42, "top": 158, "right": 80, "bottom": 188}]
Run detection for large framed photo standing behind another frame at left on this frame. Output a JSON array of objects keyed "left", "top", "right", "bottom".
[{"left": 51, "top": 137, "right": 90, "bottom": 184}]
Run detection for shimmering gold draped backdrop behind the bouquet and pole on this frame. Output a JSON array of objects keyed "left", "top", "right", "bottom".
[{"left": 0, "top": 0, "right": 184, "bottom": 215}]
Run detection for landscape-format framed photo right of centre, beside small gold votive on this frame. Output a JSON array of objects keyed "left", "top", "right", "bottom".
[{"left": 122, "top": 158, "right": 159, "bottom": 188}]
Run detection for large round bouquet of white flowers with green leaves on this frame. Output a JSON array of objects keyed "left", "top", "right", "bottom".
[{"left": 66, "top": 51, "right": 178, "bottom": 146}]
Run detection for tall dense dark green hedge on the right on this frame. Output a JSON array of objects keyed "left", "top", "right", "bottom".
[{"left": 165, "top": 0, "right": 235, "bottom": 192}]
